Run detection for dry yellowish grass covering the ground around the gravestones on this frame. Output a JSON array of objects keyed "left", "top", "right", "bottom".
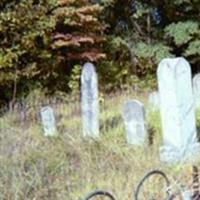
[{"left": 0, "top": 91, "right": 199, "bottom": 200}]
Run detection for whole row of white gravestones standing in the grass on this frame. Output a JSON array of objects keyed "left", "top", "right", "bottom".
[{"left": 38, "top": 58, "right": 200, "bottom": 163}]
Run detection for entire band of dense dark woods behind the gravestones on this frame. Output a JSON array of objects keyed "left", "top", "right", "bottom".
[{"left": 0, "top": 0, "right": 200, "bottom": 104}]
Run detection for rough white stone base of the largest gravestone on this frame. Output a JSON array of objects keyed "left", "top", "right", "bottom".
[{"left": 160, "top": 143, "right": 200, "bottom": 164}]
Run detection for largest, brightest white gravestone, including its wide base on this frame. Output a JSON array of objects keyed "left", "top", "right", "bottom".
[{"left": 157, "top": 58, "right": 199, "bottom": 163}]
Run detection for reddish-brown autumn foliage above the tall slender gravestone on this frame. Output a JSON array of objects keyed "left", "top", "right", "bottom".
[{"left": 52, "top": 0, "right": 105, "bottom": 62}]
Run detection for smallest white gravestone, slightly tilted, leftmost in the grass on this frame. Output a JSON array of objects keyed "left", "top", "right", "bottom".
[{"left": 41, "top": 106, "right": 57, "bottom": 136}]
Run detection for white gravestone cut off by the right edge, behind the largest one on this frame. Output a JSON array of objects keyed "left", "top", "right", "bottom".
[{"left": 192, "top": 73, "right": 200, "bottom": 108}]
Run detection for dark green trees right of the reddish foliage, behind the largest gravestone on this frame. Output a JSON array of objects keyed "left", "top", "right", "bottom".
[{"left": 99, "top": 0, "right": 200, "bottom": 87}]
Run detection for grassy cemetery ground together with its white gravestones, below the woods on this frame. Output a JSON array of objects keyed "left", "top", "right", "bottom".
[{"left": 0, "top": 57, "right": 200, "bottom": 200}]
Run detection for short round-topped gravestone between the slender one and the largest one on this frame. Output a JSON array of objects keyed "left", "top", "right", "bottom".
[{"left": 122, "top": 100, "right": 146, "bottom": 145}]
